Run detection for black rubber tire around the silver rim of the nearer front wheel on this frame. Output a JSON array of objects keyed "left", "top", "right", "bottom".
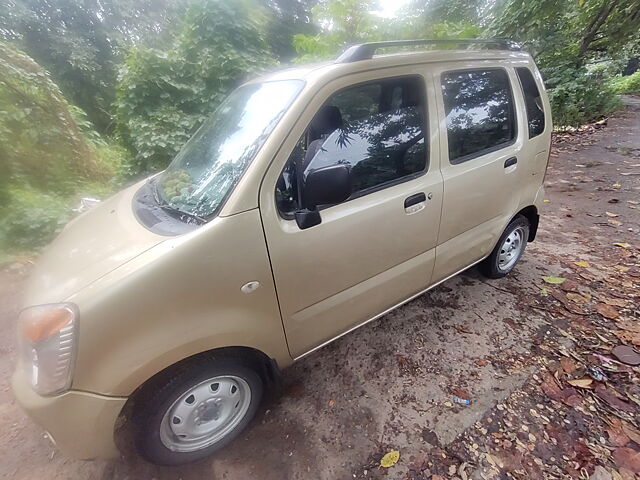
[{"left": 131, "top": 356, "right": 264, "bottom": 466}]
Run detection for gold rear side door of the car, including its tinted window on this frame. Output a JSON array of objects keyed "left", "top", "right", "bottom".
[{"left": 433, "top": 62, "right": 523, "bottom": 282}]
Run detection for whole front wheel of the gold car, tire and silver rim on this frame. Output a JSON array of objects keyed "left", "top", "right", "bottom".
[{"left": 133, "top": 358, "right": 263, "bottom": 465}]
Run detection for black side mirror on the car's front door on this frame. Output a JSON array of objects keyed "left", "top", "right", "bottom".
[{"left": 295, "top": 164, "right": 351, "bottom": 230}]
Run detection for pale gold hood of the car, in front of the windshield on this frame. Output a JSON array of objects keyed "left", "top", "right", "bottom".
[{"left": 23, "top": 182, "right": 168, "bottom": 306}]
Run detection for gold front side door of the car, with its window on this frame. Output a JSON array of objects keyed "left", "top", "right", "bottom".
[{"left": 260, "top": 67, "right": 442, "bottom": 357}]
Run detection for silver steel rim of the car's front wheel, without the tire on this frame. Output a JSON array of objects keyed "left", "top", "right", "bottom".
[{"left": 160, "top": 375, "right": 251, "bottom": 452}]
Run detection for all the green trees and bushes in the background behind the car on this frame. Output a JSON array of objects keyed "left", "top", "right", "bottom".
[{"left": 0, "top": 0, "right": 640, "bottom": 255}]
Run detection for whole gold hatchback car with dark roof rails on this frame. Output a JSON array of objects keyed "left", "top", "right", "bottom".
[{"left": 13, "top": 39, "right": 552, "bottom": 465}]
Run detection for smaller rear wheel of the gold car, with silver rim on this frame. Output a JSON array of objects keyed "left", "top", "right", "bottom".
[{"left": 480, "top": 215, "right": 529, "bottom": 278}]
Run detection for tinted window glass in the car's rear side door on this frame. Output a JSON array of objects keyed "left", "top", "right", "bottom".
[{"left": 442, "top": 68, "right": 516, "bottom": 163}]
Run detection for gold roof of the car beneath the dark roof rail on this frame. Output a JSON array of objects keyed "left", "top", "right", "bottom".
[{"left": 250, "top": 49, "right": 531, "bottom": 83}]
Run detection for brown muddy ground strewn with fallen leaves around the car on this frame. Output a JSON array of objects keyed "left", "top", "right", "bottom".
[{"left": 0, "top": 101, "right": 640, "bottom": 480}]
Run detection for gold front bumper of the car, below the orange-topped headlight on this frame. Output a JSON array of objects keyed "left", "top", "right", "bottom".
[{"left": 11, "top": 369, "right": 127, "bottom": 459}]
